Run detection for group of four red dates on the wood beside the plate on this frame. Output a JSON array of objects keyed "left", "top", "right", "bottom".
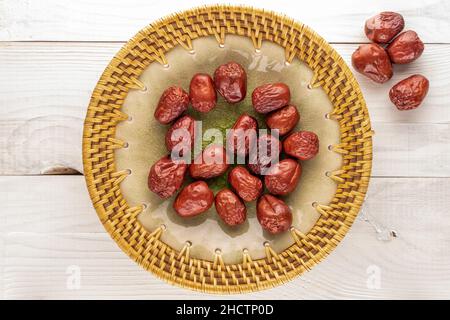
[{"left": 352, "top": 11, "right": 429, "bottom": 110}]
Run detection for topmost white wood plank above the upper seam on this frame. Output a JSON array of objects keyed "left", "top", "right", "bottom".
[{"left": 0, "top": 0, "right": 450, "bottom": 43}]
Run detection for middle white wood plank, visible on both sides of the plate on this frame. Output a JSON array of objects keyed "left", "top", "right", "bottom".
[{"left": 0, "top": 43, "right": 450, "bottom": 177}]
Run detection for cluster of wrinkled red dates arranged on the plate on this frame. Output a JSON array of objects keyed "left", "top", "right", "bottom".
[{"left": 148, "top": 62, "right": 319, "bottom": 234}]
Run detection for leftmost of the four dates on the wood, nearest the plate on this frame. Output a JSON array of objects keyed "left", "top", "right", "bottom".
[{"left": 352, "top": 43, "right": 393, "bottom": 83}]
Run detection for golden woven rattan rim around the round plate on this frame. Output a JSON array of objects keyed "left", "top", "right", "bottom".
[{"left": 83, "top": 6, "right": 372, "bottom": 293}]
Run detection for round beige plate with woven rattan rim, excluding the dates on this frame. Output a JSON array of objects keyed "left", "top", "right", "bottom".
[{"left": 83, "top": 6, "right": 373, "bottom": 294}]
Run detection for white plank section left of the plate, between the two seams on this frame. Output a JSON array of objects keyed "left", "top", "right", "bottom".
[{"left": 0, "top": 43, "right": 120, "bottom": 174}]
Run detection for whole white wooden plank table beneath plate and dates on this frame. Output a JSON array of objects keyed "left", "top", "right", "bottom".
[{"left": 0, "top": 0, "right": 450, "bottom": 299}]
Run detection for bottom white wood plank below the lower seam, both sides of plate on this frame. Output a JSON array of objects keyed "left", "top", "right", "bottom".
[{"left": 0, "top": 176, "right": 450, "bottom": 299}]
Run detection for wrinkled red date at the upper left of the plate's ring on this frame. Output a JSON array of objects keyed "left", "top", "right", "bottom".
[{"left": 154, "top": 86, "right": 189, "bottom": 124}]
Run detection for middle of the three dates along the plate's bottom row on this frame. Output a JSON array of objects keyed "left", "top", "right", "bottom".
[{"left": 215, "top": 189, "right": 247, "bottom": 226}]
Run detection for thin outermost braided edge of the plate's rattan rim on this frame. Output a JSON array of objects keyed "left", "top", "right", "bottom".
[{"left": 83, "top": 5, "right": 372, "bottom": 293}]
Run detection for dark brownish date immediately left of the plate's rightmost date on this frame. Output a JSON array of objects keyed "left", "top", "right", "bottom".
[{"left": 247, "top": 134, "right": 282, "bottom": 174}]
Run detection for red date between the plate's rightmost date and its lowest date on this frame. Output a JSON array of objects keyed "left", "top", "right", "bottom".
[{"left": 264, "top": 159, "right": 302, "bottom": 195}]
